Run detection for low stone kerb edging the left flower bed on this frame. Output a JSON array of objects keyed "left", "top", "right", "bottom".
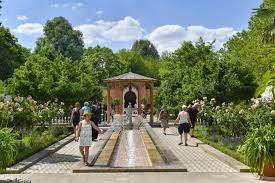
[{"left": 6, "top": 135, "right": 74, "bottom": 174}]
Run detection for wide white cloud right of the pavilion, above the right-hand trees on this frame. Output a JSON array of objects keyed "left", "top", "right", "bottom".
[{"left": 146, "top": 25, "right": 236, "bottom": 52}]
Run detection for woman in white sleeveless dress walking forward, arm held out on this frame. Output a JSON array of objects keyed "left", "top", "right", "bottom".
[{"left": 78, "top": 111, "right": 102, "bottom": 166}]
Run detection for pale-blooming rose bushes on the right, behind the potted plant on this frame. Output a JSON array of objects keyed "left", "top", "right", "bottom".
[{"left": 196, "top": 98, "right": 275, "bottom": 137}]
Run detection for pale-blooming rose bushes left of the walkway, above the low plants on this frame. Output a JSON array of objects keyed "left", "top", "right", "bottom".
[{"left": 0, "top": 97, "right": 64, "bottom": 132}]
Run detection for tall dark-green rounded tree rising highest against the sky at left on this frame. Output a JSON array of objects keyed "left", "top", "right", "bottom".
[{"left": 35, "top": 17, "right": 84, "bottom": 60}]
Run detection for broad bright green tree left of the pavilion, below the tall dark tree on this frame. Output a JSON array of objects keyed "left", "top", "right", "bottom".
[{"left": 8, "top": 55, "right": 101, "bottom": 105}]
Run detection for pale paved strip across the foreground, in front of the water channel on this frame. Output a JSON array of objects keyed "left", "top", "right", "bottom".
[{"left": 0, "top": 172, "right": 266, "bottom": 183}]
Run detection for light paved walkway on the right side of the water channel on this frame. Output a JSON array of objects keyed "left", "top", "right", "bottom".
[{"left": 153, "top": 127, "right": 237, "bottom": 172}]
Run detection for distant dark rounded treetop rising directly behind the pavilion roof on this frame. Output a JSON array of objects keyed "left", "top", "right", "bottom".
[{"left": 131, "top": 39, "right": 159, "bottom": 59}]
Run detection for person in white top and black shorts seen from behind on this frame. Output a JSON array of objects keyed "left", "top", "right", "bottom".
[{"left": 176, "top": 105, "right": 192, "bottom": 146}]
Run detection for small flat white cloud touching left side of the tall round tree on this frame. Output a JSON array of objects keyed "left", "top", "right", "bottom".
[{"left": 13, "top": 23, "right": 43, "bottom": 35}]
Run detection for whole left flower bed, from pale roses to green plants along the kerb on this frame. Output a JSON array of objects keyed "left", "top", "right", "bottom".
[{"left": 0, "top": 97, "right": 70, "bottom": 171}]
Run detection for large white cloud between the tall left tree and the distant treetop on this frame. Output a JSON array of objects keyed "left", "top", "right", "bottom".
[{"left": 75, "top": 16, "right": 144, "bottom": 46}]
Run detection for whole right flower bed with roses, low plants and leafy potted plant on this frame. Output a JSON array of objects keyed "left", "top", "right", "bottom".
[{"left": 196, "top": 98, "right": 275, "bottom": 176}]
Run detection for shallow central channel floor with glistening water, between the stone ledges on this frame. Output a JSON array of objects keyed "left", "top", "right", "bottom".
[{"left": 111, "top": 130, "right": 152, "bottom": 167}]
